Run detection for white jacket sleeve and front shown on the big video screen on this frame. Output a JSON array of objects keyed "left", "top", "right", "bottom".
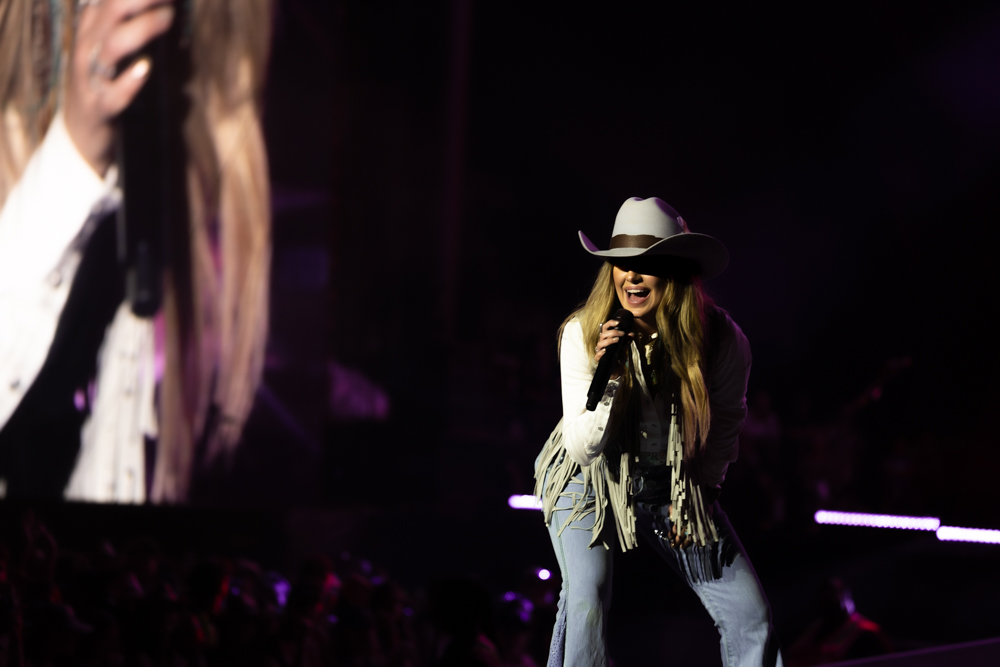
[{"left": 0, "top": 113, "right": 158, "bottom": 503}]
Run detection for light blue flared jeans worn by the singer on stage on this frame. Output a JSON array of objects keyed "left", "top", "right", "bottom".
[{"left": 548, "top": 478, "right": 782, "bottom": 667}]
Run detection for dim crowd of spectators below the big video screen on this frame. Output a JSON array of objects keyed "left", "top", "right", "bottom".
[{"left": 0, "top": 511, "right": 552, "bottom": 667}]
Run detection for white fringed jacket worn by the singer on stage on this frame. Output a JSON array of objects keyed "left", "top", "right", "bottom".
[{"left": 535, "top": 308, "right": 751, "bottom": 551}]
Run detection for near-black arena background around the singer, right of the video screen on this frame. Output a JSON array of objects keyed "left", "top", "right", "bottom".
[{"left": 7, "top": 0, "right": 1000, "bottom": 665}]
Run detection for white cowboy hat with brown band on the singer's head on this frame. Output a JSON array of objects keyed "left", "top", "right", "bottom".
[{"left": 579, "top": 197, "right": 729, "bottom": 280}]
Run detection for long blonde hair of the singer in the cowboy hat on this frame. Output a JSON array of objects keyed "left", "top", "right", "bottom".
[{"left": 559, "top": 258, "right": 712, "bottom": 460}]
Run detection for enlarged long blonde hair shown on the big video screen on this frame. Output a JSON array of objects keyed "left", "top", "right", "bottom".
[{"left": 0, "top": 0, "right": 271, "bottom": 502}]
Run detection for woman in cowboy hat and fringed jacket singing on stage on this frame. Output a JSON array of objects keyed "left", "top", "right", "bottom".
[{"left": 535, "top": 197, "right": 781, "bottom": 667}]
